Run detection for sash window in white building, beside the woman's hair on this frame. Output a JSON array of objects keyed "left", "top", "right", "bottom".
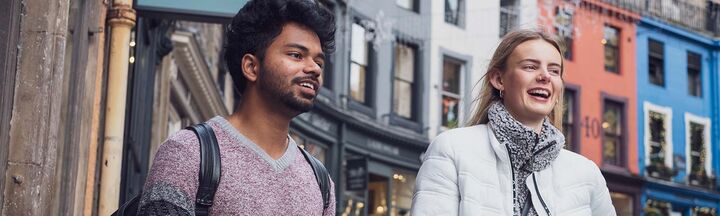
[{"left": 441, "top": 57, "right": 463, "bottom": 128}]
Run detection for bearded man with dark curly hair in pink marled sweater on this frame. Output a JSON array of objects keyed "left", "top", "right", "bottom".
[{"left": 139, "top": 0, "right": 335, "bottom": 215}]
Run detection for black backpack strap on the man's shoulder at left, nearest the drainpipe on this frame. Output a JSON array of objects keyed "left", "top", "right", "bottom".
[{"left": 187, "top": 123, "right": 221, "bottom": 215}]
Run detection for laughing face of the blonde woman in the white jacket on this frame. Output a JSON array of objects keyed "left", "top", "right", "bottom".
[{"left": 491, "top": 39, "right": 563, "bottom": 125}]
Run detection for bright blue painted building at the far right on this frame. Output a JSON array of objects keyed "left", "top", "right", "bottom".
[{"left": 636, "top": 18, "right": 720, "bottom": 215}]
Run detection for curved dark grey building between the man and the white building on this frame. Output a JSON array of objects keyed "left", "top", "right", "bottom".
[{"left": 304, "top": 0, "right": 430, "bottom": 215}]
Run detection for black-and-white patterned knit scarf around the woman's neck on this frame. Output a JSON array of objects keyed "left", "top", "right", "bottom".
[{"left": 488, "top": 102, "right": 565, "bottom": 215}]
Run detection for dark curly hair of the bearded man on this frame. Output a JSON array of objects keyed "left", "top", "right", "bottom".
[{"left": 225, "top": 0, "right": 335, "bottom": 94}]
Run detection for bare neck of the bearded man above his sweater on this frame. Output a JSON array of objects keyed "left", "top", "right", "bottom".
[{"left": 228, "top": 93, "right": 292, "bottom": 159}]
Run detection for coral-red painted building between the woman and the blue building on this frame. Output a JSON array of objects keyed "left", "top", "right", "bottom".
[{"left": 538, "top": 0, "right": 642, "bottom": 215}]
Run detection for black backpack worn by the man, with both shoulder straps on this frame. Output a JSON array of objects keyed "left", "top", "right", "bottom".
[{"left": 112, "top": 123, "right": 330, "bottom": 216}]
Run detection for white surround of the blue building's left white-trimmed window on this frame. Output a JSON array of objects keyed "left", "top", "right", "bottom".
[{"left": 643, "top": 101, "right": 673, "bottom": 168}]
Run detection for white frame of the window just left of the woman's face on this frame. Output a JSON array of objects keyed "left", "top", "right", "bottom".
[{"left": 437, "top": 58, "right": 467, "bottom": 134}]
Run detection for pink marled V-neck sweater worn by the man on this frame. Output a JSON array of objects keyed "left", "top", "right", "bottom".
[{"left": 139, "top": 117, "right": 335, "bottom": 216}]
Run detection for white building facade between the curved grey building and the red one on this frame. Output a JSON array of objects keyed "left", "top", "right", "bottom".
[{"left": 428, "top": 0, "right": 538, "bottom": 136}]
